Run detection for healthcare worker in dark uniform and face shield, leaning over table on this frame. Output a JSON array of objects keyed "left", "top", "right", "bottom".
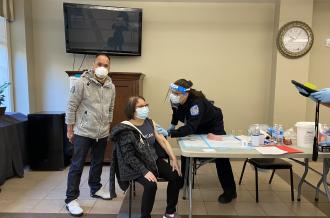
[{"left": 168, "top": 79, "right": 237, "bottom": 203}]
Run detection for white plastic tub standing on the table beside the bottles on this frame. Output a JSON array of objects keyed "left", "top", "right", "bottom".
[{"left": 295, "top": 122, "right": 315, "bottom": 148}]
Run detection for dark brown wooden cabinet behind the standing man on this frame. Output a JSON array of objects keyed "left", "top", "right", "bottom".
[{"left": 66, "top": 71, "right": 144, "bottom": 163}]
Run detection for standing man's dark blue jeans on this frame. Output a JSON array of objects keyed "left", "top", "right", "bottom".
[{"left": 65, "top": 135, "right": 107, "bottom": 203}]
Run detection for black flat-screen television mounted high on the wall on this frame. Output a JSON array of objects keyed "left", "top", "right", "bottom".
[{"left": 63, "top": 3, "right": 142, "bottom": 55}]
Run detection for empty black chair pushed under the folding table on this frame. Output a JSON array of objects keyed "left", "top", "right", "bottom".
[{"left": 239, "top": 158, "right": 294, "bottom": 202}]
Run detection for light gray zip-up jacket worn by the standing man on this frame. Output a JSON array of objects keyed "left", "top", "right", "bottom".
[{"left": 65, "top": 70, "right": 116, "bottom": 139}]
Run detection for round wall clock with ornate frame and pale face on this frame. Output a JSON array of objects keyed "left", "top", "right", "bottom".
[{"left": 277, "top": 21, "right": 313, "bottom": 58}]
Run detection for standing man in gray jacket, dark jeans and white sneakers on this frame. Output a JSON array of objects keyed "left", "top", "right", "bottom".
[{"left": 65, "top": 54, "right": 115, "bottom": 216}]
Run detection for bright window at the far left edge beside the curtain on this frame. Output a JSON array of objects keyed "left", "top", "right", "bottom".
[{"left": 0, "top": 17, "right": 12, "bottom": 111}]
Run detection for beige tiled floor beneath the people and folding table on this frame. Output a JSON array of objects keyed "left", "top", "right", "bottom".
[{"left": 0, "top": 160, "right": 326, "bottom": 216}]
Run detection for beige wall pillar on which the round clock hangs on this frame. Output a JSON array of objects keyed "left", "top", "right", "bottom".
[{"left": 273, "top": 0, "right": 313, "bottom": 128}]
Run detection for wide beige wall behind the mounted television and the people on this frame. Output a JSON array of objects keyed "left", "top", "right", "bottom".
[{"left": 25, "top": 0, "right": 275, "bottom": 133}]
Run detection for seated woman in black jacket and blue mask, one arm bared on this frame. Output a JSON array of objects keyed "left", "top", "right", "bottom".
[{"left": 110, "top": 96, "right": 183, "bottom": 218}]
